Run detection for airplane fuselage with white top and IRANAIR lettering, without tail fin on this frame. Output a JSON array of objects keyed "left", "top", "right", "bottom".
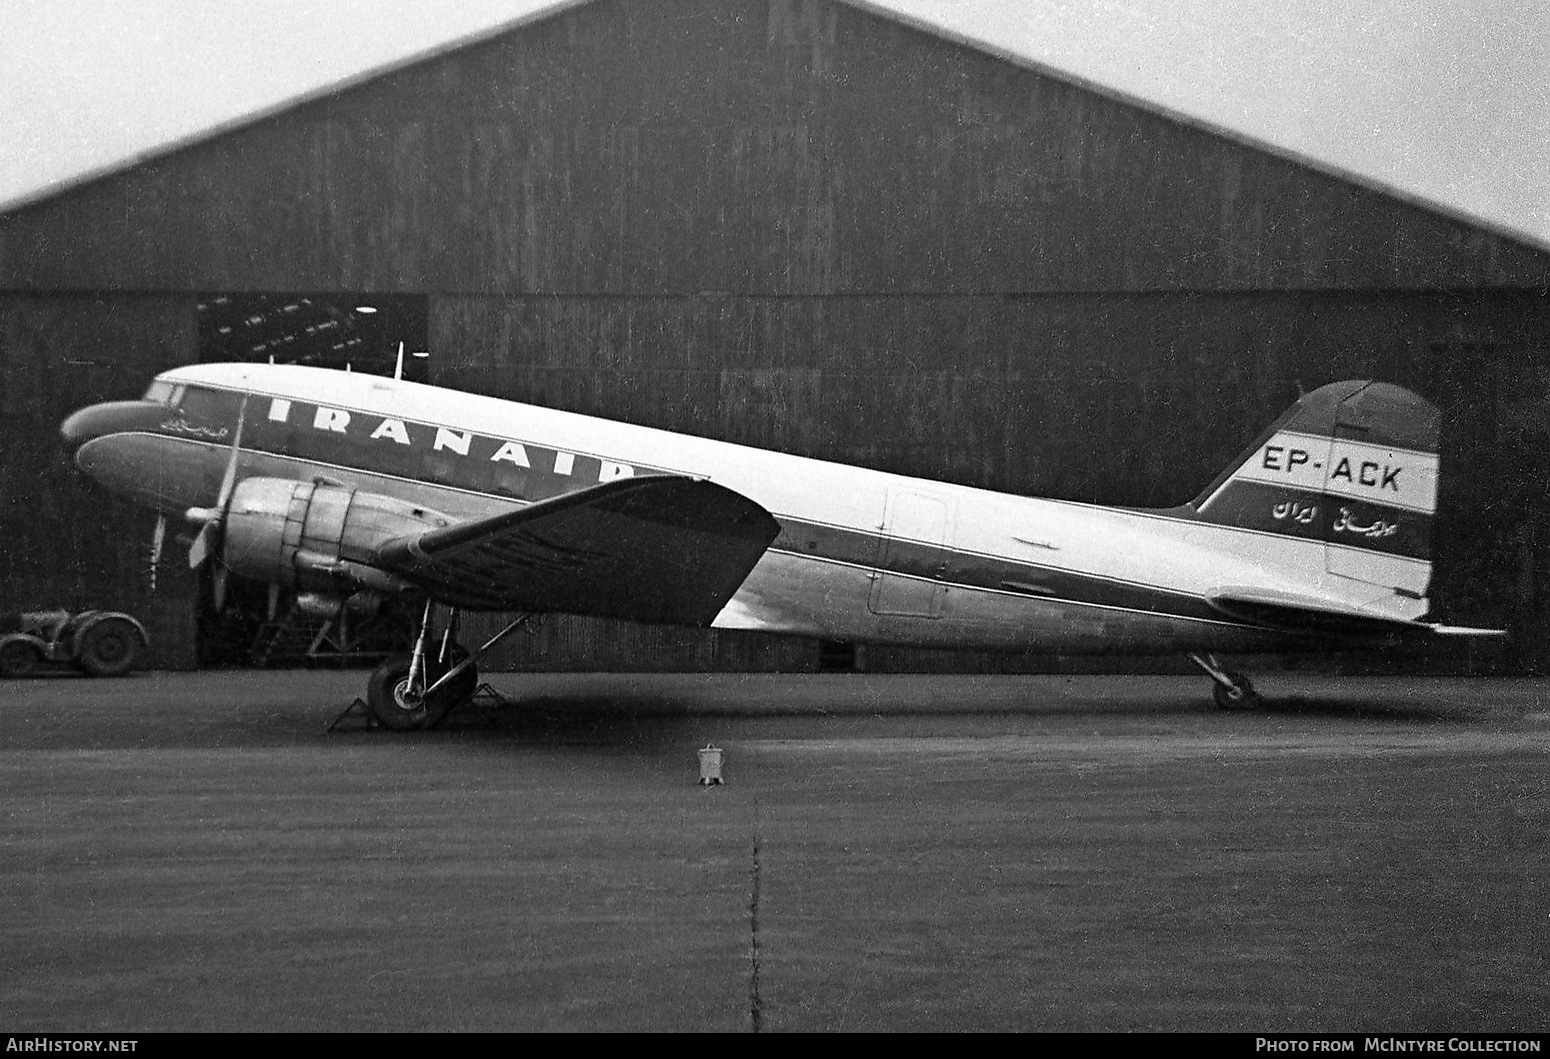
[{"left": 64, "top": 364, "right": 1424, "bottom": 653}]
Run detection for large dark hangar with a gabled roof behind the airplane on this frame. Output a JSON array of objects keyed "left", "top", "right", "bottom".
[{"left": 0, "top": 0, "right": 1550, "bottom": 671}]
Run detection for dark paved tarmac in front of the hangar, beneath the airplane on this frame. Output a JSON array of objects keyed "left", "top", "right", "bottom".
[{"left": 0, "top": 671, "right": 1550, "bottom": 1034}]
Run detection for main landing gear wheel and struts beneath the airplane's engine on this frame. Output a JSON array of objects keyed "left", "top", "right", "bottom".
[{"left": 366, "top": 600, "right": 535, "bottom": 732}]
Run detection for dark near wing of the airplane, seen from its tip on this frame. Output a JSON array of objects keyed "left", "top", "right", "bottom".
[{"left": 377, "top": 474, "right": 780, "bottom": 625}]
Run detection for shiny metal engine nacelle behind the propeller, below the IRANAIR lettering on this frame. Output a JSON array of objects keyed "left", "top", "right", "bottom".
[{"left": 222, "top": 478, "right": 453, "bottom": 595}]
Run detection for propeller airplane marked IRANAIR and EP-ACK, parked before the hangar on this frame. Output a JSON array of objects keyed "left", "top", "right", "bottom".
[{"left": 60, "top": 361, "right": 1502, "bottom": 730}]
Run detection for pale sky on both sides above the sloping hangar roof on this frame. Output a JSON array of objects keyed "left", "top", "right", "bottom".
[{"left": 9, "top": 0, "right": 1550, "bottom": 245}]
